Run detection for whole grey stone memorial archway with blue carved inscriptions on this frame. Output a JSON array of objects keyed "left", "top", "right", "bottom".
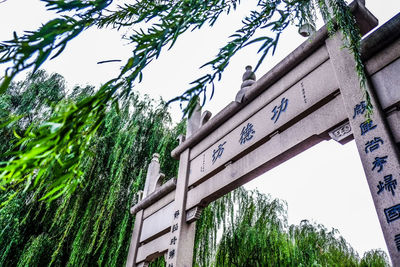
[{"left": 126, "top": 1, "right": 400, "bottom": 267}]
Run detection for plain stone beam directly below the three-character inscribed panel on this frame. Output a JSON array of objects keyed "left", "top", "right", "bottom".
[{"left": 186, "top": 95, "right": 347, "bottom": 210}]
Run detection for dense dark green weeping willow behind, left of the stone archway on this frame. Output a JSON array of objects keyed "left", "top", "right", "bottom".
[{"left": 0, "top": 72, "right": 183, "bottom": 266}]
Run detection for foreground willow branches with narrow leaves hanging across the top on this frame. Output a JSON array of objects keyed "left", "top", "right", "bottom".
[{"left": 0, "top": 0, "right": 372, "bottom": 199}]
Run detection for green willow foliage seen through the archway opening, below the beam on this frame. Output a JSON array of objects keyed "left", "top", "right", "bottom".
[{"left": 194, "top": 188, "right": 389, "bottom": 267}]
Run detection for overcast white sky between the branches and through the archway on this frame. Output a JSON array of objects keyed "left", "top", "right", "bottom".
[{"left": 0, "top": 0, "right": 400, "bottom": 256}]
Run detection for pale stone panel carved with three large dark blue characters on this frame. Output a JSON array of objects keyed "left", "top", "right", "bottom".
[{"left": 189, "top": 61, "right": 338, "bottom": 186}]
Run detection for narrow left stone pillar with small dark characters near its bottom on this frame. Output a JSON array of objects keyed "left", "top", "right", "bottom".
[{"left": 166, "top": 149, "right": 196, "bottom": 267}]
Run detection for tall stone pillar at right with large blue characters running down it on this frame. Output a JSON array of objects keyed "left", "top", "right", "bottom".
[{"left": 326, "top": 32, "right": 400, "bottom": 266}]
